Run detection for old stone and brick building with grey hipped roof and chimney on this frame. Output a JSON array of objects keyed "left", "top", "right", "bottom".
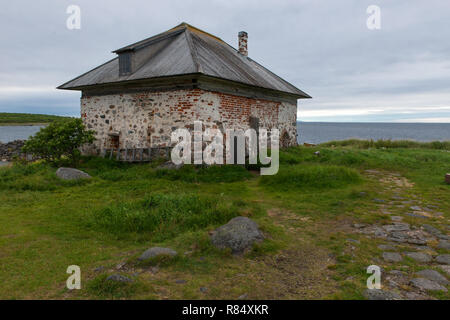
[{"left": 58, "top": 23, "right": 310, "bottom": 152}]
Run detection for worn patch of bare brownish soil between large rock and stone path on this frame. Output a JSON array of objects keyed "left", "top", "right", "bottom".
[{"left": 251, "top": 208, "right": 336, "bottom": 299}]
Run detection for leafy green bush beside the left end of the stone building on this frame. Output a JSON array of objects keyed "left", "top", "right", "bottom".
[{"left": 22, "top": 119, "right": 95, "bottom": 166}]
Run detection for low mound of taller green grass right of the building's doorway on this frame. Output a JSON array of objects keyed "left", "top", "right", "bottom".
[{"left": 260, "top": 165, "right": 361, "bottom": 190}]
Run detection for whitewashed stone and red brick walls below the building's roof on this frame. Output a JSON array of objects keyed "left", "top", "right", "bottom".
[{"left": 81, "top": 89, "right": 297, "bottom": 153}]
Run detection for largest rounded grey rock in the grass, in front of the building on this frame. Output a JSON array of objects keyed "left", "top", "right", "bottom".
[{"left": 211, "top": 217, "right": 264, "bottom": 254}]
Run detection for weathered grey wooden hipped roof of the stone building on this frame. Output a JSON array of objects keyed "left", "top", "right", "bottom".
[{"left": 58, "top": 23, "right": 310, "bottom": 98}]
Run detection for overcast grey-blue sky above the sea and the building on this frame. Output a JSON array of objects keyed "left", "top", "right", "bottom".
[{"left": 0, "top": 0, "right": 450, "bottom": 122}]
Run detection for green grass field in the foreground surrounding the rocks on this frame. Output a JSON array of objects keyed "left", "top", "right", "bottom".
[{"left": 0, "top": 140, "right": 450, "bottom": 299}]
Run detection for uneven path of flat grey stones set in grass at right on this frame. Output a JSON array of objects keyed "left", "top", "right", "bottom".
[{"left": 353, "top": 170, "right": 450, "bottom": 300}]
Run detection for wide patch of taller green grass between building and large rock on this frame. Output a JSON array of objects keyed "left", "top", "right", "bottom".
[{"left": 88, "top": 194, "right": 241, "bottom": 241}]
